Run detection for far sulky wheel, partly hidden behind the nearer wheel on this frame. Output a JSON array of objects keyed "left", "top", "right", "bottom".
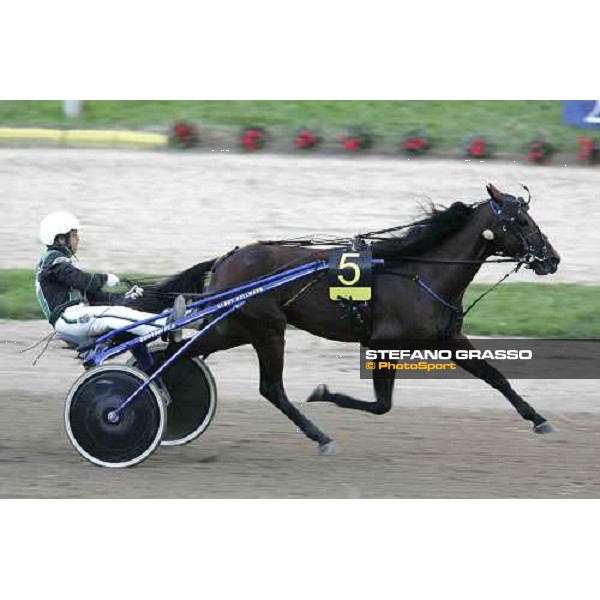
[{"left": 127, "top": 345, "right": 217, "bottom": 446}]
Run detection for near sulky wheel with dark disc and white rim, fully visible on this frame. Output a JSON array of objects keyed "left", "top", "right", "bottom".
[{"left": 65, "top": 365, "right": 166, "bottom": 468}]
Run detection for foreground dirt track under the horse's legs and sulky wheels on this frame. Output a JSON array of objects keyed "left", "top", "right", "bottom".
[{"left": 0, "top": 321, "right": 600, "bottom": 498}]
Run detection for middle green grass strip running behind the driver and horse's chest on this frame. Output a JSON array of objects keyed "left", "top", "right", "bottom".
[{"left": 0, "top": 269, "right": 600, "bottom": 339}]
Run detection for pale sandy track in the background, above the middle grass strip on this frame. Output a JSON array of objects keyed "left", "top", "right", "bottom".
[{"left": 0, "top": 148, "right": 600, "bottom": 283}]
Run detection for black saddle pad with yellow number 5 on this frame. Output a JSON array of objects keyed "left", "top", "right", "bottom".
[{"left": 329, "top": 249, "right": 373, "bottom": 302}]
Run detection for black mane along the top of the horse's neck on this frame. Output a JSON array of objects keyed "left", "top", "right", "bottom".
[{"left": 366, "top": 202, "right": 478, "bottom": 258}]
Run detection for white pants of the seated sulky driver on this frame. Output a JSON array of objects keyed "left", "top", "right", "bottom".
[{"left": 54, "top": 304, "right": 166, "bottom": 338}]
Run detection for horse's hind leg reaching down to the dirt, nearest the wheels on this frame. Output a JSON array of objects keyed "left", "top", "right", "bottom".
[{"left": 252, "top": 331, "right": 334, "bottom": 454}]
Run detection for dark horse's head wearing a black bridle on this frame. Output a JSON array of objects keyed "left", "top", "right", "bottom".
[{"left": 482, "top": 184, "right": 560, "bottom": 275}]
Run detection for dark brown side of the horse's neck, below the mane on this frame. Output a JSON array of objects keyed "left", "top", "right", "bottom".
[{"left": 420, "top": 215, "right": 489, "bottom": 301}]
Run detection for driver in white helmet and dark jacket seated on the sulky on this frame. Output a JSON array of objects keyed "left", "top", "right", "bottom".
[{"left": 35, "top": 212, "right": 185, "bottom": 338}]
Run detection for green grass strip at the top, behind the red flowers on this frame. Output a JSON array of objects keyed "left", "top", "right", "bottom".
[{"left": 0, "top": 100, "right": 589, "bottom": 152}]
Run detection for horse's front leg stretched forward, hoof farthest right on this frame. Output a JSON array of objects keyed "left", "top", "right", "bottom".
[{"left": 453, "top": 335, "right": 554, "bottom": 433}]
